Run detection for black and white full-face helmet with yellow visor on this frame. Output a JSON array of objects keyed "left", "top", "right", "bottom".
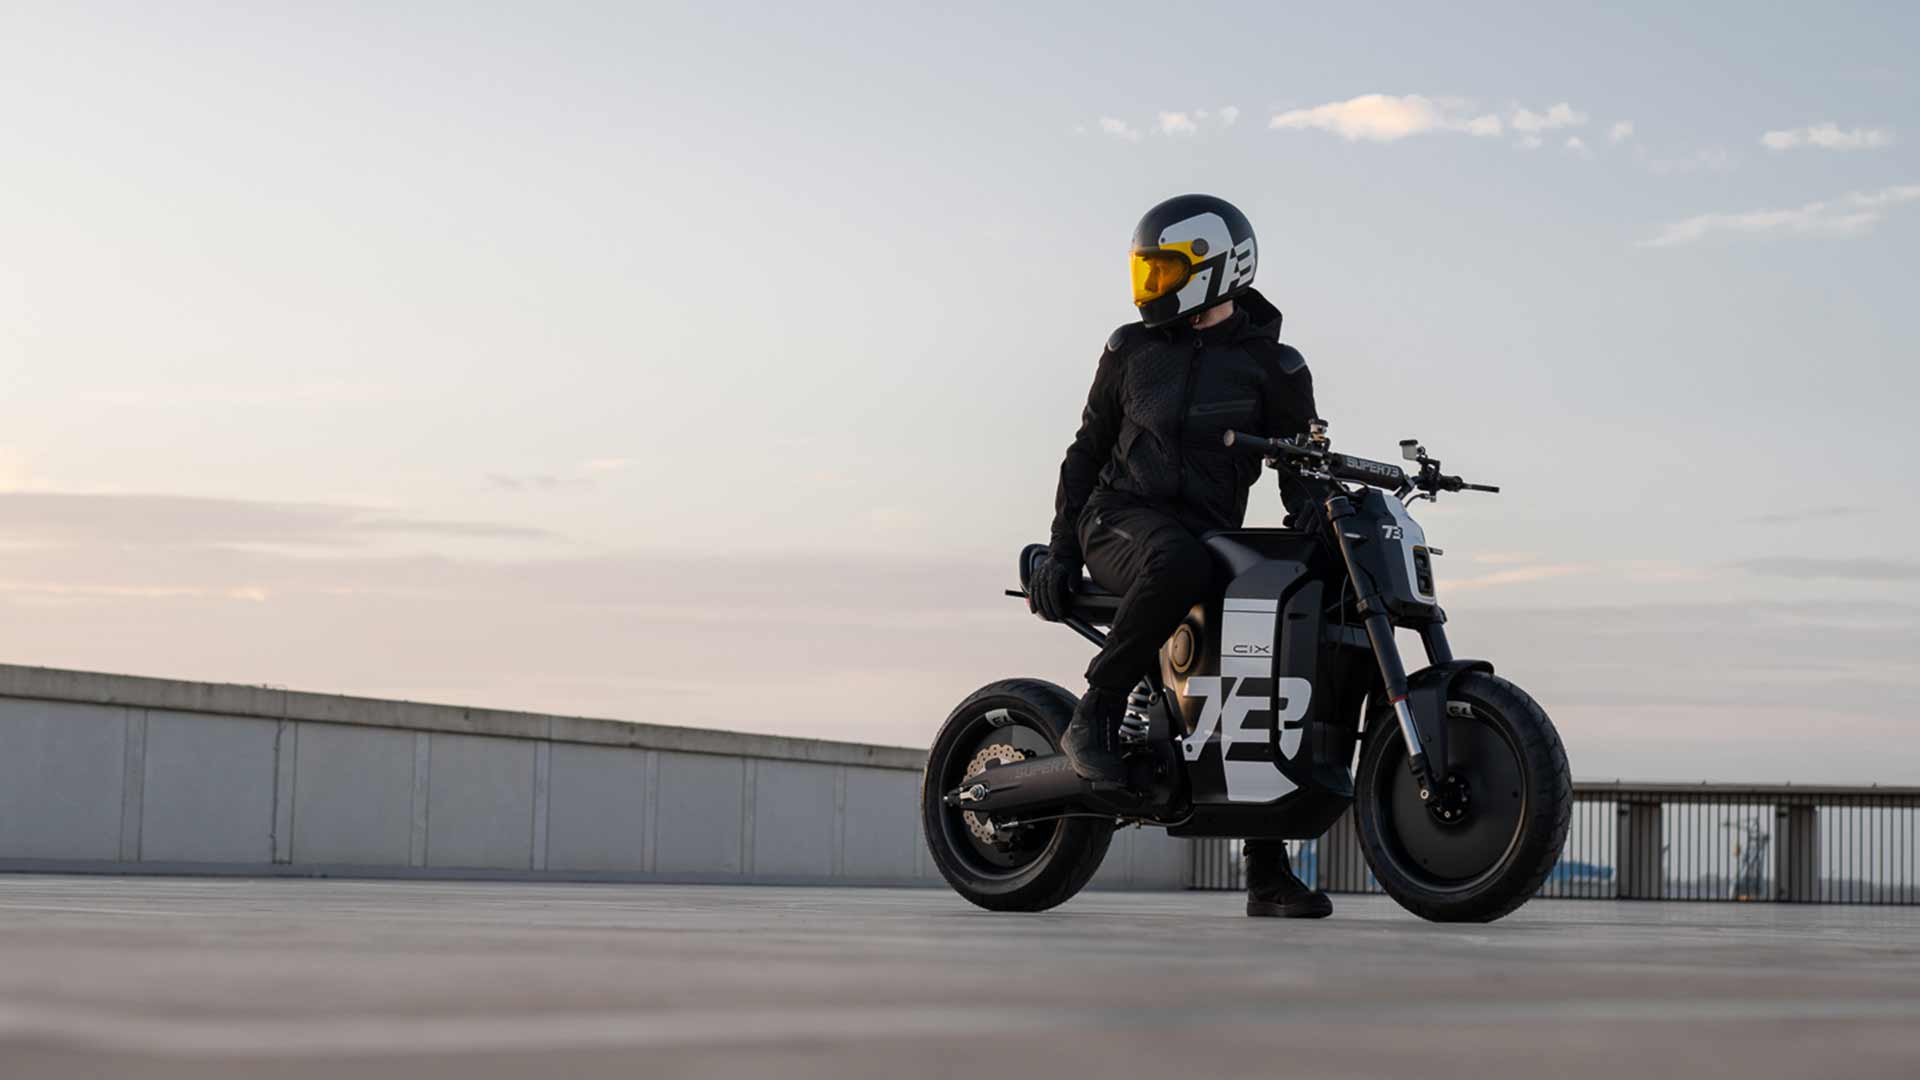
[{"left": 1133, "top": 194, "right": 1258, "bottom": 327}]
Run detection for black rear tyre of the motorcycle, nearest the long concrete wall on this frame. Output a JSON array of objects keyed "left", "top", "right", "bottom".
[{"left": 920, "top": 678, "right": 1114, "bottom": 911}]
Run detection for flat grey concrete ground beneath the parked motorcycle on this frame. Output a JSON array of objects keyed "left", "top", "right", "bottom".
[{"left": 0, "top": 876, "right": 1920, "bottom": 1080}]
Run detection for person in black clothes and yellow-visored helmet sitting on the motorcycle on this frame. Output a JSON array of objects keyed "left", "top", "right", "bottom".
[{"left": 1029, "top": 194, "right": 1332, "bottom": 919}]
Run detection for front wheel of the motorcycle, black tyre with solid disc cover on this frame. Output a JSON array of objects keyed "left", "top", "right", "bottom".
[{"left": 1354, "top": 671, "right": 1572, "bottom": 922}]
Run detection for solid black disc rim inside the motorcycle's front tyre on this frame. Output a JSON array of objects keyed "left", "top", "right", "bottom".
[{"left": 1371, "top": 701, "right": 1526, "bottom": 892}]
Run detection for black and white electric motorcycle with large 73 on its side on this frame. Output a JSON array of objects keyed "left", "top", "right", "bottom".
[{"left": 920, "top": 421, "right": 1572, "bottom": 922}]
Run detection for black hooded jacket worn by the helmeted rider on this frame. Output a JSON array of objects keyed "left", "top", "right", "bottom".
[{"left": 1048, "top": 290, "right": 1315, "bottom": 561}]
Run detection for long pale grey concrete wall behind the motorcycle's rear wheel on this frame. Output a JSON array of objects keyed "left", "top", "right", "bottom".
[{"left": 0, "top": 665, "right": 1188, "bottom": 888}]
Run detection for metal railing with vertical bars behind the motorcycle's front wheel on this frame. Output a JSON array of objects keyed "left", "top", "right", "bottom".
[{"left": 1192, "top": 782, "right": 1920, "bottom": 903}]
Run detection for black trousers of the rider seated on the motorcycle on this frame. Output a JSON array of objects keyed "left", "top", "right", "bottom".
[{"left": 1081, "top": 507, "right": 1286, "bottom": 864}]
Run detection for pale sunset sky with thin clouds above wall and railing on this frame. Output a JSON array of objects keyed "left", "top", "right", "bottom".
[{"left": 0, "top": 2, "right": 1920, "bottom": 784}]
